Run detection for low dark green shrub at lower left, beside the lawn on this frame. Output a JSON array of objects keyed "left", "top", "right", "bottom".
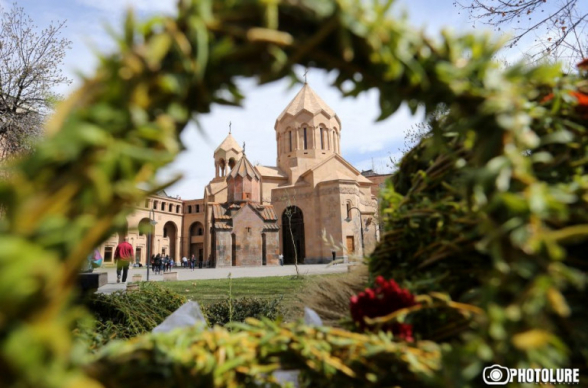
[{"left": 79, "top": 282, "right": 186, "bottom": 350}]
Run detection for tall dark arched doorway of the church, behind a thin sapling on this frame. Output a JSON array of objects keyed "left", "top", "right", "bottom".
[{"left": 282, "top": 206, "right": 306, "bottom": 264}]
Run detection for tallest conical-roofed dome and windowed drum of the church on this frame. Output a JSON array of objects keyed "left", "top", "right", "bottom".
[{"left": 274, "top": 82, "right": 341, "bottom": 181}]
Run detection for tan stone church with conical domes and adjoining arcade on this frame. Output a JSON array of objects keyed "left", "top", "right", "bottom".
[{"left": 100, "top": 84, "right": 381, "bottom": 267}]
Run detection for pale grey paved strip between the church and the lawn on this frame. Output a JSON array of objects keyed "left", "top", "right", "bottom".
[{"left": 94, "top": 264, "right": 348, "bottom": 294}]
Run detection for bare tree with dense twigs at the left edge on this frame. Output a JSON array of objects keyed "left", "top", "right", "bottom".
[{"left": 0, "top": 3, "right": 71, "bottom": 160}]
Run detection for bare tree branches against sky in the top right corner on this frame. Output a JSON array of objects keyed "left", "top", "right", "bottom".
[{"left": 454, "top": 0, "right": 588, "bottom": 63}]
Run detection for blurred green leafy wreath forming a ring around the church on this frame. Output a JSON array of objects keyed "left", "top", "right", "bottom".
[{"left": 0, "top": 0, "right": 588, "bottom": 388}]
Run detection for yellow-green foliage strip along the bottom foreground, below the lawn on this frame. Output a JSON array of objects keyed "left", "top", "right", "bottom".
[{"left": 86, "top": 319, "right": 439, "bottom": 388}]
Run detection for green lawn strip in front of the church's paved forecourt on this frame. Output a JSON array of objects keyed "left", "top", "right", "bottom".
[{"left": 161, "top": 274, "right": 350, "bottom": 320}]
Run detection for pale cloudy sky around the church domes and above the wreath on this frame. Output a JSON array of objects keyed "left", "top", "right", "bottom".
[{"left": 9, "top": 0, "right": 584, "bottom": 199}]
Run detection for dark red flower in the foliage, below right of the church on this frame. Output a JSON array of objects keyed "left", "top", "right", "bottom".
[{"left": 350, "top": 276, "right": 416, "bottom": 341}]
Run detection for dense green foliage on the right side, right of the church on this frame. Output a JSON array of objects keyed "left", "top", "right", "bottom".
[{"left": 370, "top": 49, "right": 588, "bottom": 386}]
